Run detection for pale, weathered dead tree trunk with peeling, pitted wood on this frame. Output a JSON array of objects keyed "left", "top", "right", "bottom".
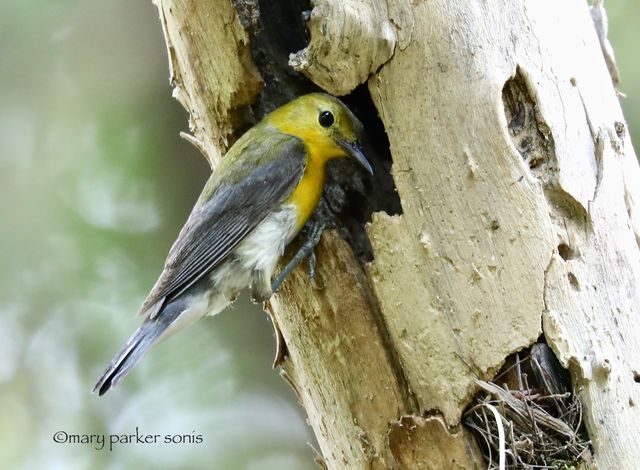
[{"left": 156, "top": 0, "right": 640, "bottom": 469}]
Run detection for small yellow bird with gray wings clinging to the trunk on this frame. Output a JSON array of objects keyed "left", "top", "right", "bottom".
[{"left": 93, "top": 93, "right": 373, "bottom": 396}]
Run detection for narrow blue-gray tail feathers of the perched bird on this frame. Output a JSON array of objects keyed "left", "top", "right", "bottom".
[{"left": 93, "top": 319, "right": 169, "bottom": 395}]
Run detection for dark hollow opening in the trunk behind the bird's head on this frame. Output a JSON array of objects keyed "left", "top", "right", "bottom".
[{"left": 233, "top": 0, "right": 402, "bottom": 262}]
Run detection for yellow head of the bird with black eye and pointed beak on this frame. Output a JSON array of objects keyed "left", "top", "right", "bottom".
[{"left": 265, "top": 93, "right": 373, "bottom": 173}]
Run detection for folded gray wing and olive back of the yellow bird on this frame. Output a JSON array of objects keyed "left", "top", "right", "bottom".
[{"left": 140, "top": 133, "right": 306, "bottom": 317}]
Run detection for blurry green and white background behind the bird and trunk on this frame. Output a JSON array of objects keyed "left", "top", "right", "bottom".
[{"left": 0, "top": 0, "right": 640, "bottom": 469}]
